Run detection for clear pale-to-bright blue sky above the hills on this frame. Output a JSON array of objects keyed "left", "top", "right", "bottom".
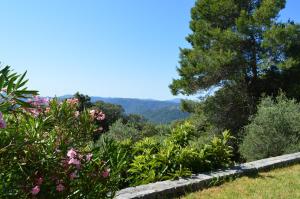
[{"left": 0, "top": 0, "right": 300, "bottom": 99}]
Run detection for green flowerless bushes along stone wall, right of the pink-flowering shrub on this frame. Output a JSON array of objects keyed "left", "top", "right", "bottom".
[{"left": 97, "top": 122, "right": 233, "bottom": 188}]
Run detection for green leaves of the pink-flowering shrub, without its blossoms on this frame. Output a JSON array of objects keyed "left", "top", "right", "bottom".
[{"left": 0, "top": 100, "right": 116, "bottom": 198}]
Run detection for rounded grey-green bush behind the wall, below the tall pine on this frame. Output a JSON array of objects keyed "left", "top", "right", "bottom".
[{"left": 240, "top": 95, "right": 300, "bottom": 161}]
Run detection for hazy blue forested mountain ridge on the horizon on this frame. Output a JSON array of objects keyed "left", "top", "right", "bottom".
[{"left": 60, "top": 95, "right": 189, "bottom": 123}]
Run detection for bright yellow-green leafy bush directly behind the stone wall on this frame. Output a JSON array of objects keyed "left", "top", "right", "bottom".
[{"left": 128, "top": 122, "right": 232, "bottom": 185}]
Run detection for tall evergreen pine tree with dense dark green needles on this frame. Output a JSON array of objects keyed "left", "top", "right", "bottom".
[{"left": 170, "top": 0, "right": 300, "bottom": 107}]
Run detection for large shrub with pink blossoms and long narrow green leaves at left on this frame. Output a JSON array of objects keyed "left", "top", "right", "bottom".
[{"left": 0, "top": 68, "right": 117, "bottom": 198}]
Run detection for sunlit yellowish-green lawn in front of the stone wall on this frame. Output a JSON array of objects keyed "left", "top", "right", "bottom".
[{"left": 181, "top": 164, "right": 300, "bottom": 199}]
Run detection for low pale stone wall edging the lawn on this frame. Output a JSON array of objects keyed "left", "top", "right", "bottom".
[{"left": 115, "top": 152, "right": 300, "bottom": 199}]
